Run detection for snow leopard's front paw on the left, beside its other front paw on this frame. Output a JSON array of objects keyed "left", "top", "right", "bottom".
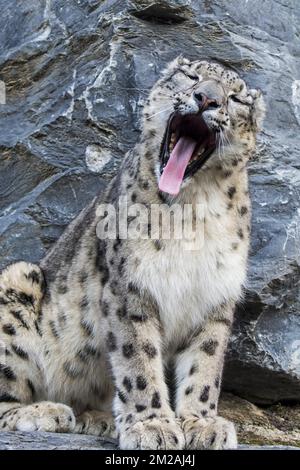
[{"left": 120, "top": 418, "right": 185, "bottom": 450}]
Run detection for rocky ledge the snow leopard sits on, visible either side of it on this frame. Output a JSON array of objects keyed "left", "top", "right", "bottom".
[{"left": 0, "top": 394, "right": 300, "bottom": 450}]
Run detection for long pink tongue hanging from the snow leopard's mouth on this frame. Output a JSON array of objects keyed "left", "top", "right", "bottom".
[{"left": 158, "top": 137, "right": 197, "bottom": 195}]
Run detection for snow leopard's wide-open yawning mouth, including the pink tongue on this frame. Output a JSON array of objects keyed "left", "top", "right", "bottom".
[{"left": 159, "top": 112, "right": 216, "bottom": 195}]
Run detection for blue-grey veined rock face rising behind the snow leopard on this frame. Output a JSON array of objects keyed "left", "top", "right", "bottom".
[{"left": 0, "top": 0, "right": 300, "bottom": 403}]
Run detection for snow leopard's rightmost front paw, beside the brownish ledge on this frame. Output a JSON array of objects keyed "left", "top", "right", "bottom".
[{"left": 181, "top": 416, "right": 237, "bottom": 450}]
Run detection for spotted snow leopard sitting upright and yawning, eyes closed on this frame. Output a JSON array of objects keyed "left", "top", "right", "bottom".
[{"left": 0, "top": 57, "right": 264, "bottom": 449}]
